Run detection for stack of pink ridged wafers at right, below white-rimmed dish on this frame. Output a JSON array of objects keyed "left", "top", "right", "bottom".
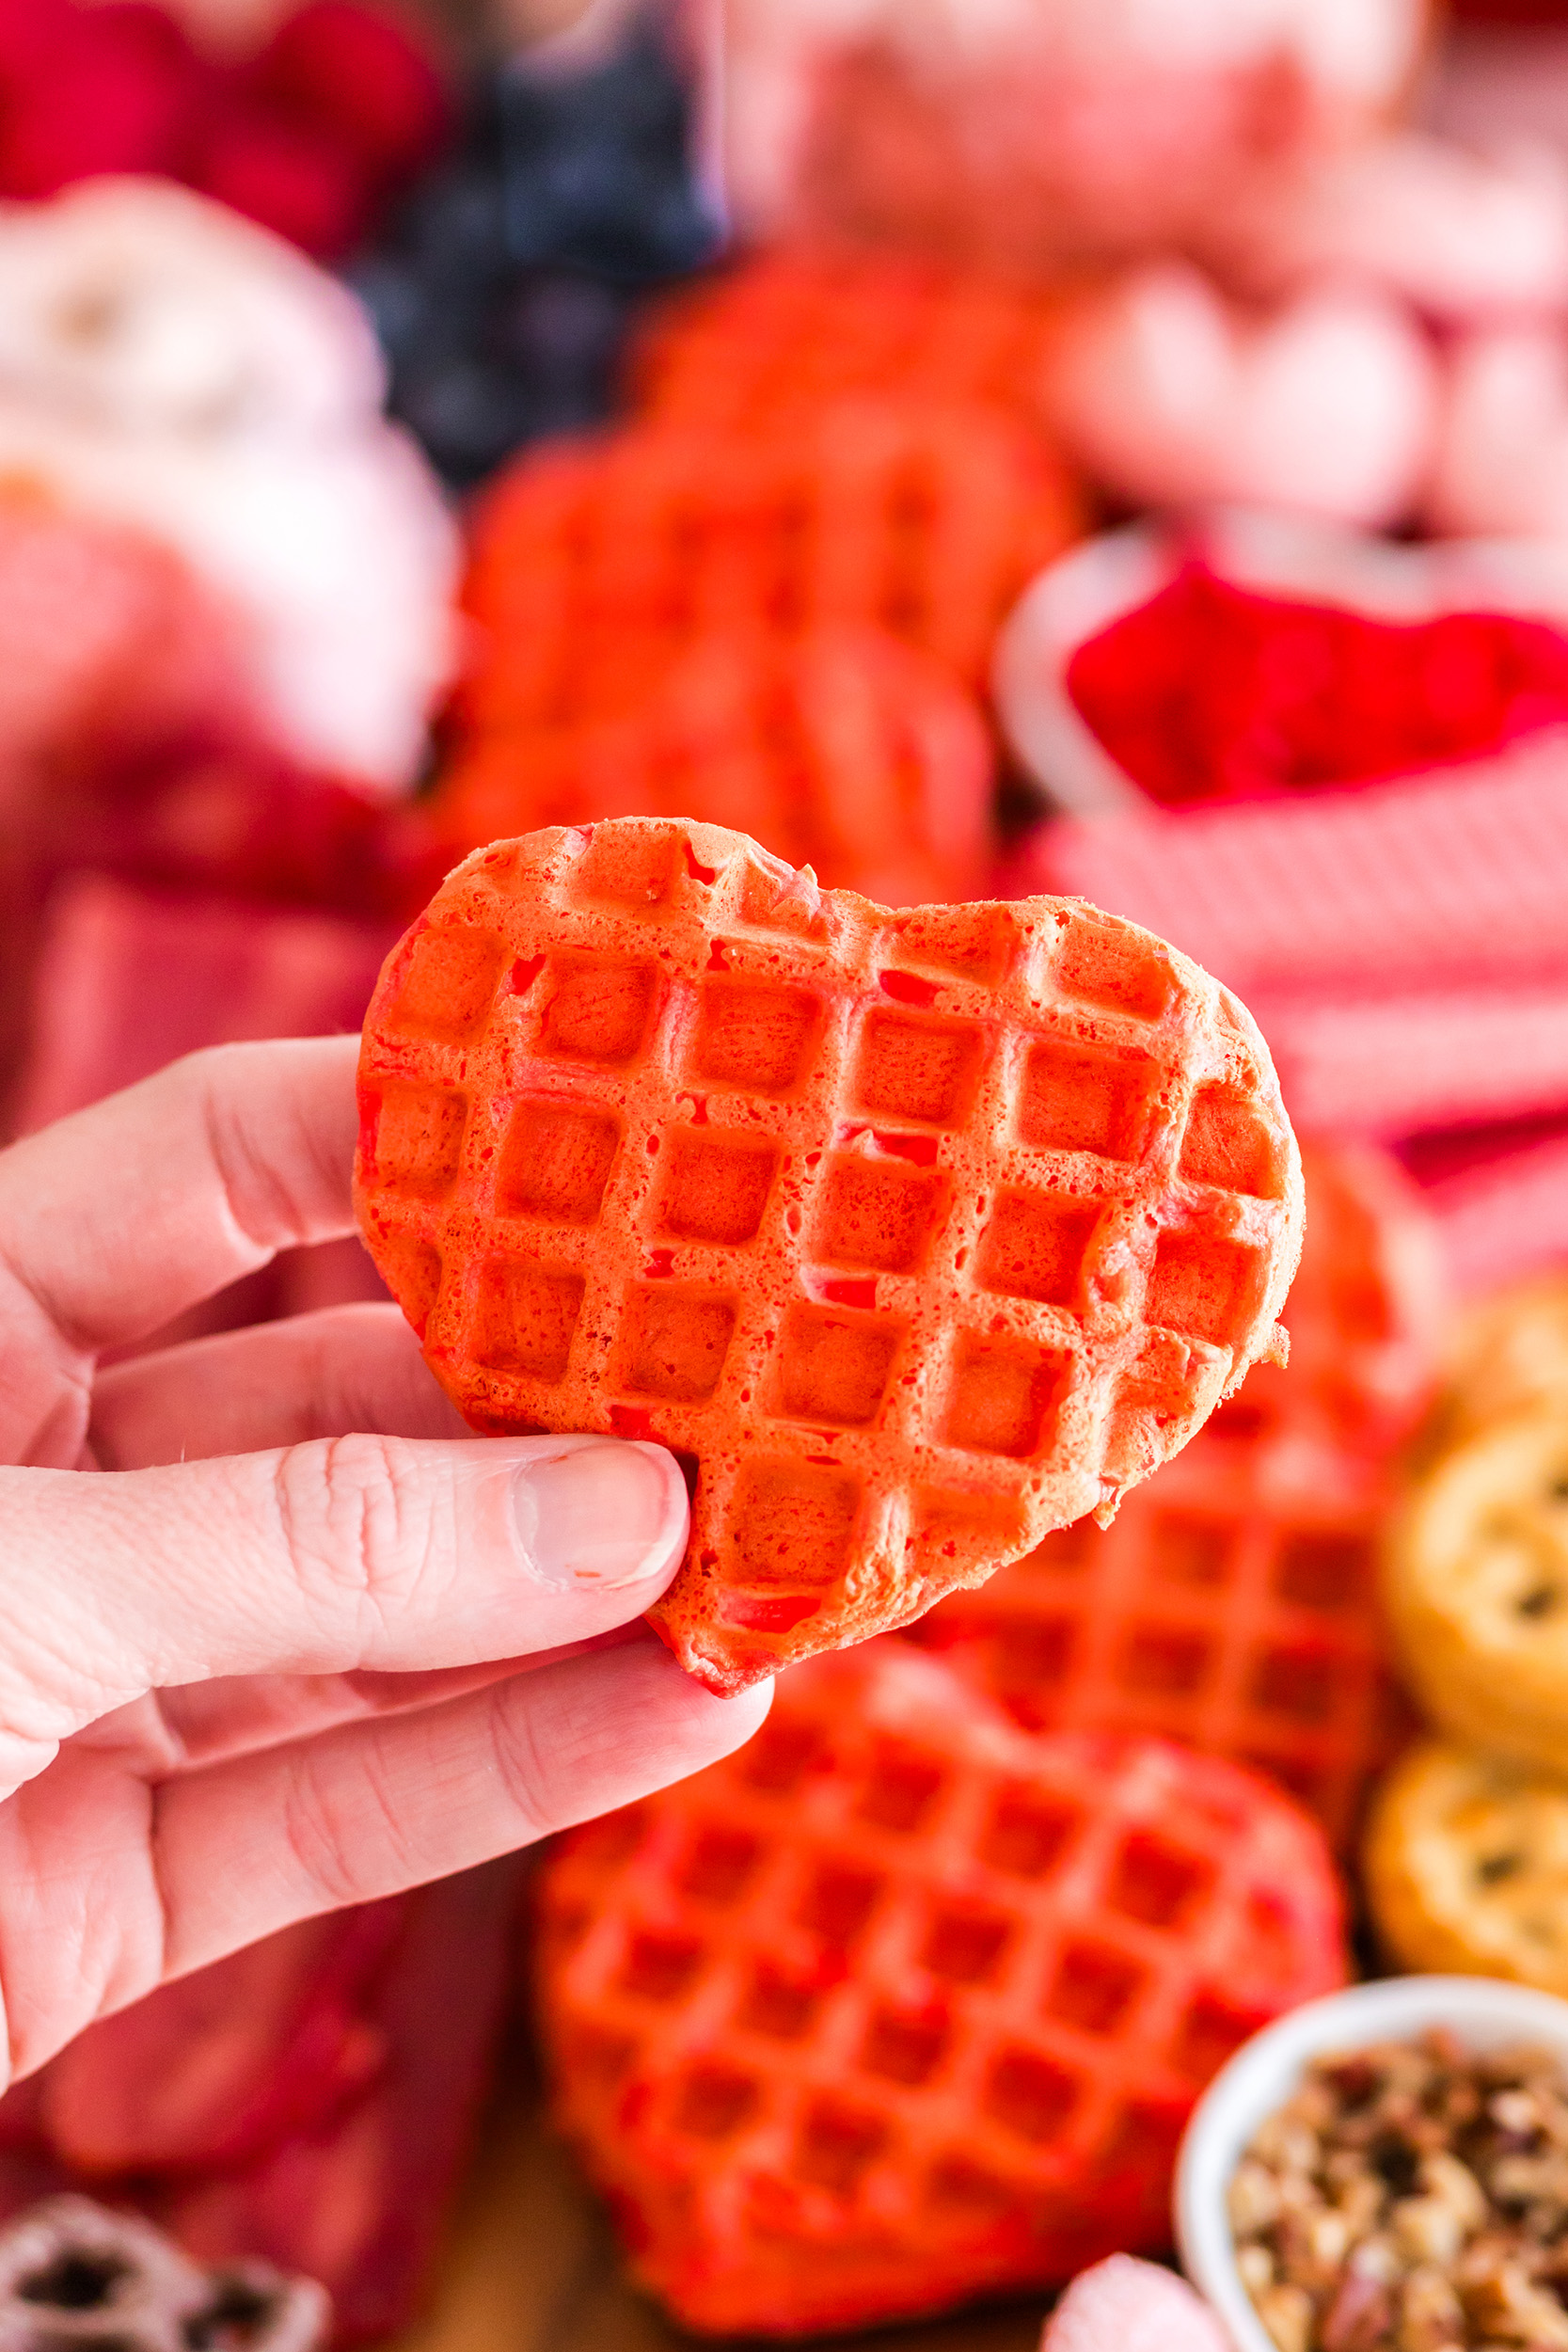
[{"left": 1004, "top": 753, "right": 1568, "bottom": 1294}]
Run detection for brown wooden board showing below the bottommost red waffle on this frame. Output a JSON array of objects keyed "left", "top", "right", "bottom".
[{"left": 397, "top": 2056, "right": 1046, "bottom": 2352}]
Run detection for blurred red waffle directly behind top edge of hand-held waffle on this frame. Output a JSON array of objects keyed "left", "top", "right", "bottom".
[{"left": 433, "top": 626, "right": 992, "bottom": 906}]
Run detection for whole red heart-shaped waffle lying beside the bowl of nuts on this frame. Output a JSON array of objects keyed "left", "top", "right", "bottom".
[{"left": 538, "top": 1642, "right": 1345, "bottom": 2336}]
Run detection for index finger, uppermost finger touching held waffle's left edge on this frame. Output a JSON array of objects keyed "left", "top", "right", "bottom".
[{"left": 0, "top": 1038, "right": 359, "bottom": 1369}]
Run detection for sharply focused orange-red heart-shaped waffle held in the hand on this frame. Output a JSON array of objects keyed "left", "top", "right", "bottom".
[{"left": 355, "top": 818, "right": 1300, "bottom": 1692}]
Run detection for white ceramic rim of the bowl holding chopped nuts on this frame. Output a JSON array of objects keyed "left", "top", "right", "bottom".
[{"left": 1176, "top": 1976, "right": 1568, "bottom": 2352}]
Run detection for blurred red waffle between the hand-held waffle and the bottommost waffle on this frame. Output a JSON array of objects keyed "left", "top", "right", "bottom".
[{"left": 914, "top": 1430, "right": 1411, "bottom": 1849}]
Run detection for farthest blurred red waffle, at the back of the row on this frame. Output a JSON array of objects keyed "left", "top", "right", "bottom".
[{"left": 630, "top": 247, "right": 1081, "bottom": 431}]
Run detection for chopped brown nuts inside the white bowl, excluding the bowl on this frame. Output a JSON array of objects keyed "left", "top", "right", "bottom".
[{"left": 1229, "top": 2030, "right": 1568, "bottom": 2352}]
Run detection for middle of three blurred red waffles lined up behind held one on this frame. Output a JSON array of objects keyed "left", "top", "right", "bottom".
[{"left": 458, "top": 398, "right": 1079, "bottom": 701}]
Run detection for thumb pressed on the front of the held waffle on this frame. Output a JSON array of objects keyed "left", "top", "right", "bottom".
[{"left": 0, "top": 1438, "right": 689, "bottom": 1792}]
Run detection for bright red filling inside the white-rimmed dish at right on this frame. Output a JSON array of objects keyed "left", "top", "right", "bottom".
[{"left": 1068, "top": 563, "right": 1568, "bottom": 807}]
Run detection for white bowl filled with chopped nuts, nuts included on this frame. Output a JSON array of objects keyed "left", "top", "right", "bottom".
[{"left": 1176, "top": 1976, "right": 1568, "bottom": 2352}]
